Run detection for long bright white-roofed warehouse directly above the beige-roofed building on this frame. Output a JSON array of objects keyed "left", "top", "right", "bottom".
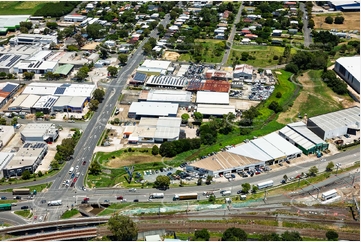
[{"left": 128, "top": 102, "right": 178, "bottom": 119}]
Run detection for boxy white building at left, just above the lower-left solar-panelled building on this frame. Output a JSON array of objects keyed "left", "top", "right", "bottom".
[{"left": 20, "top": 123, "right": 59, "bottom": 142}]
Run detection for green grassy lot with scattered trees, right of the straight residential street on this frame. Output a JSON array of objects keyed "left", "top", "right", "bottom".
[{"left": 227, "top": 45, "right": 296, "bottom": 68}]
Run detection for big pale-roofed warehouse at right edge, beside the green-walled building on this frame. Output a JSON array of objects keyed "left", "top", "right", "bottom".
[{"left": 307, "top": 107, "right": 360, "bottom": 140}]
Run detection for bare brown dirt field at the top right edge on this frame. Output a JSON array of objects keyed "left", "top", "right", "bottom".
[{"left": 312, "top": 12, "right": 360, "bottom": 31}]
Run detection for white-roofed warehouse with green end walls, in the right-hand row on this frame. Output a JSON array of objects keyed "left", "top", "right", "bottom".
[{"left": 279, "top": 122, "right": 328, "bottom": 155}]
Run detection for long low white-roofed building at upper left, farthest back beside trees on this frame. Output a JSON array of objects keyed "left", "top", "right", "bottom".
[{"left": 9, "top": 34, "right": 58, "bottom": 45}]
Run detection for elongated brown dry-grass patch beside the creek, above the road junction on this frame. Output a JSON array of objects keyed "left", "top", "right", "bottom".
[{"left": 106, "top": 154, "right": 161, "bottom": 168}]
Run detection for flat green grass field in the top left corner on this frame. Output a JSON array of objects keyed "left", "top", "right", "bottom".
[{"left": 0, "top": 1, "right": 46, "bottom": 15}]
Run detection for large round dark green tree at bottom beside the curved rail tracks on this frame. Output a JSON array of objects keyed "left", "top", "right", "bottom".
[{"left": 108, "top": 213, "right": 138, "bottom": 241}]
